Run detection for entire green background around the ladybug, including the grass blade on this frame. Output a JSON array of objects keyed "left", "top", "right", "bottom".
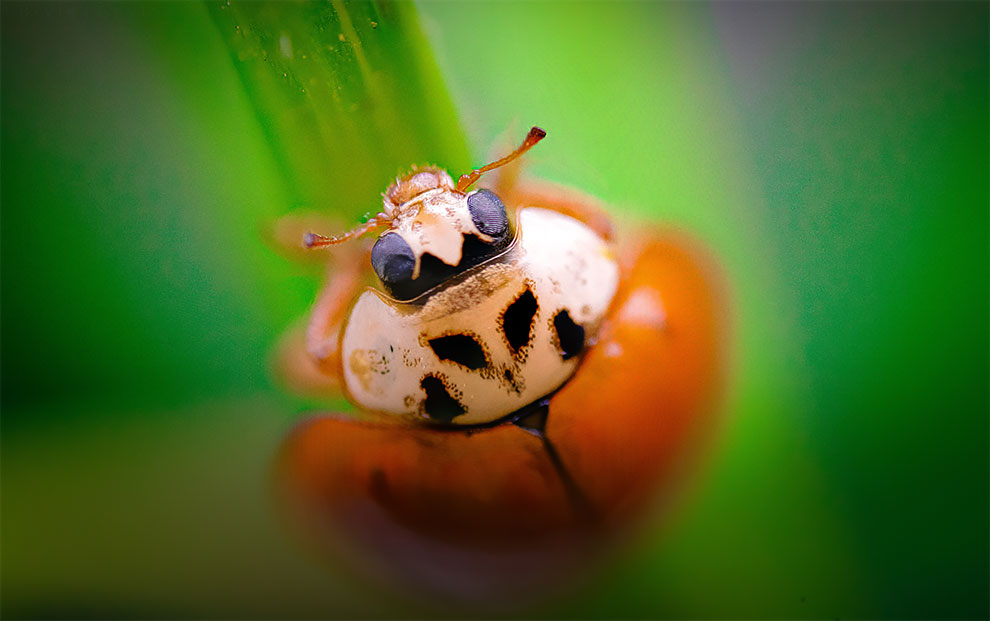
[{"left": 0, "top": 0, "right": 990, "bottom": 618}]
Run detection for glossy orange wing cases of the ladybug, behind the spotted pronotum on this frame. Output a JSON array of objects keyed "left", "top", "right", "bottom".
[{"left": 279, "top": 234, "right": 725, "bottom": 598}]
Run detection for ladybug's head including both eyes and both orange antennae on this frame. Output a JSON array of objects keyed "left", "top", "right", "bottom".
[{"left": 304, "top": 127, "right": 546, "bottom": 300}]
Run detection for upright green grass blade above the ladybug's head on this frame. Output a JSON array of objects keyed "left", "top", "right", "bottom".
[{"left": 209, "top": 0, "right": 468, "bottom": 217}]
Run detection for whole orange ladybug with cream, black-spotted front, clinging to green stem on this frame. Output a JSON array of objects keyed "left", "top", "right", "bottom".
[{"left": 278, "top": 127, "right": 725, "bottom": 601}]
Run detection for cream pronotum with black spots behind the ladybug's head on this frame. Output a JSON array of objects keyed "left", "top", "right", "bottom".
[{"left": 341, "top": 208, "right": 619, "bottom": 425}]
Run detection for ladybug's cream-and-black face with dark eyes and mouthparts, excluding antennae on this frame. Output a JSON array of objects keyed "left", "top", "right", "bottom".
[{"left": 371, "top": 184, "right": 513, "bottom": 300}]
